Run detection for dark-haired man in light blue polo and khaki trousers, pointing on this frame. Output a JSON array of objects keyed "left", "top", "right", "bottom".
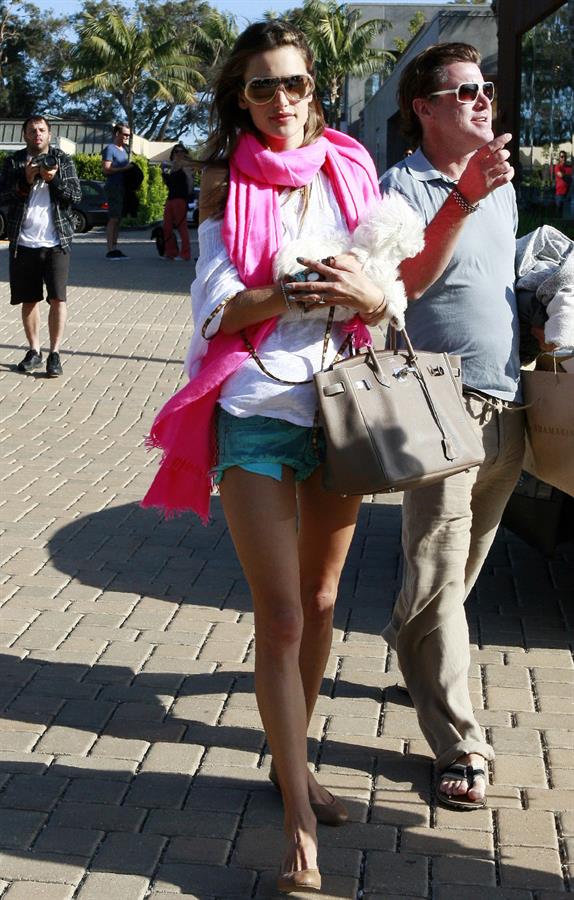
[{"left": 382, "top": 43, "right": 524, "bottom": 809}]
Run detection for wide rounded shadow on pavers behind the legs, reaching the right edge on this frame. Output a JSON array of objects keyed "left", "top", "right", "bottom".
[{"left": 49, "top": 497, "right": 574, "bottom": 649}]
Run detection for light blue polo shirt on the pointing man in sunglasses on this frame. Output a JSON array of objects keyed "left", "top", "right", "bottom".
[{"left": 381, "top": 148, "right": 520, "bottom": 401}]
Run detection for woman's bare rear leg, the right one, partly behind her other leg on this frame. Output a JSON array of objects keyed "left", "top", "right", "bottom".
[{"left": 299, "top": 469, "right": 362, "bottom": 803}]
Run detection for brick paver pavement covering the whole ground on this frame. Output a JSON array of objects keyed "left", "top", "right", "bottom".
[{"left": 0, "top": 232, "right": 574, "bottom": 900}]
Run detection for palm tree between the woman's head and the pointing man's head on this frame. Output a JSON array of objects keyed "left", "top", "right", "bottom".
[{"left": 291, "top": 0, "right": 394, "bottom": 128}]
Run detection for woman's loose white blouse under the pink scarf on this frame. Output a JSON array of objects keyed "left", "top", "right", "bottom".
[{"left": 186, "top": 171, "right": 354, "bottom": 426}]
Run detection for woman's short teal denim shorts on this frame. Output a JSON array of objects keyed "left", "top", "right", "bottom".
[{"left": 212, "top": 408, "right": 325, "bottom": 484}]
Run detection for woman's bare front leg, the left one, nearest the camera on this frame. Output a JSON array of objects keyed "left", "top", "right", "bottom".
[{"left": 221, "top": 467, "right": 317, "bottom": 872}]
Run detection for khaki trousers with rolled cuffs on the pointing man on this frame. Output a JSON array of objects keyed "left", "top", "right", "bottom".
[{"left": 383, "top": 394, "right": 524, "bottom": 771}]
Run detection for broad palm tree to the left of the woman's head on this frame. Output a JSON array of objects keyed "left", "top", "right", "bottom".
[{"left": 61, "top": 9, "right": 205, "bottom": 142}]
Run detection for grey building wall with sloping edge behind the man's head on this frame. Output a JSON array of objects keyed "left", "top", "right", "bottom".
[{"left": 364, "top": 7, "right": 498, "bottom": 175}]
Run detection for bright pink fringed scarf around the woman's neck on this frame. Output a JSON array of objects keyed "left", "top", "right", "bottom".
[{"left": 141, "top": 128, "right": 380, "bottom": 523}]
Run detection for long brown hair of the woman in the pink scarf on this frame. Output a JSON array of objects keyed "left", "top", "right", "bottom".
[{"left": 203, "top": 19, "right": 325, "bottom": 163}]
